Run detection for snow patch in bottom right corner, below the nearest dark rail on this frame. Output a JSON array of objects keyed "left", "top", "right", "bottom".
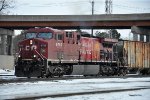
[{"left": 38, "top": 89, "right": 150, "bottom": 100}]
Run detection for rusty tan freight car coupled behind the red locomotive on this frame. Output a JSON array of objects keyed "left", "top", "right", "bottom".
[{"left": 120, "top": 41, "right": 150, "bottom": 74}]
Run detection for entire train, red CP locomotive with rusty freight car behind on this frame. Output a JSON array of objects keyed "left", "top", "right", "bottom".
[{"left": 15, "top": 28, "right": 150, "bottom": 78}]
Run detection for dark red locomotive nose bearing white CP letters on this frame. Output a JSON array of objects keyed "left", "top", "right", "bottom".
[{"left": 19, "top": 38, "right": 47, "bottom": 60}]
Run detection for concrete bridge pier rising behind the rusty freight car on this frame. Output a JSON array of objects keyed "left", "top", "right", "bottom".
[{"left": 131, "top": 26, "right": 150, "bottom": 42}]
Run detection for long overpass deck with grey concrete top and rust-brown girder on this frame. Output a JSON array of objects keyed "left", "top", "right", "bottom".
[{"left": 0, "top": 13, "right": 150, "bottom": 29}]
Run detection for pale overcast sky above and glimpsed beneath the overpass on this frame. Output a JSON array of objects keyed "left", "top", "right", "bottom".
[{"left": 9, "top": 0, "right": 150, "bottom": 38}]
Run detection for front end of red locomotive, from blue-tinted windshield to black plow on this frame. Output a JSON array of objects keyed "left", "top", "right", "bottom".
[{"left": 15, "top": 29, "right": 53, "bottom": 77}]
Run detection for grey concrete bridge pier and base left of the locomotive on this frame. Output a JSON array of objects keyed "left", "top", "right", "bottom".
[{"left": 0, "top": 28, "right": 14, "bottom": 69}]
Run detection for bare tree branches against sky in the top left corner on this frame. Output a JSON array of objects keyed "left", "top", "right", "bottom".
[{"left": 0, "top": 0, "right": 14, "bottom": 13}]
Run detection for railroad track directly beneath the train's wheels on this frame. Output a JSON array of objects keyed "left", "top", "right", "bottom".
[{"left": 0, "top": 75, "right": 150, "bottom": 84}]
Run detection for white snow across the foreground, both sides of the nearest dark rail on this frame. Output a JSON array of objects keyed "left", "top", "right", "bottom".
[{"left": 0, "top": 77, "right": 150, "bottom": 100}]
